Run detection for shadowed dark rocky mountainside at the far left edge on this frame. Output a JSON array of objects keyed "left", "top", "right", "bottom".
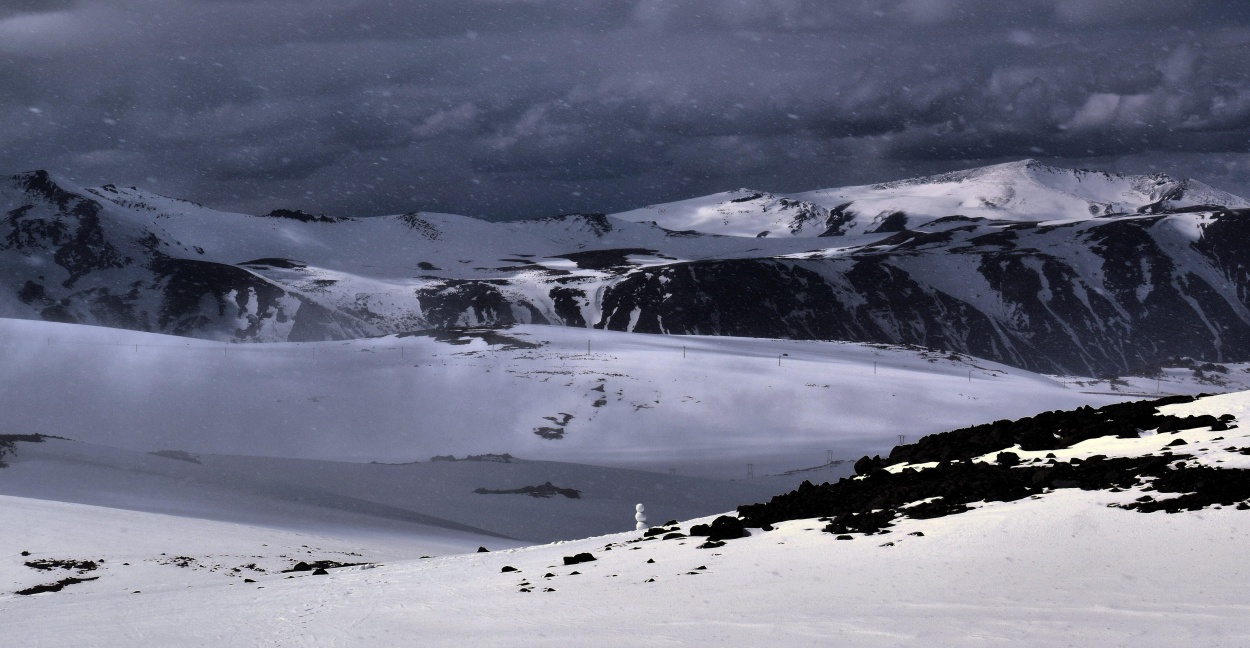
[{"left": 0, "top": 171, "right": 376, "bottom": 342}]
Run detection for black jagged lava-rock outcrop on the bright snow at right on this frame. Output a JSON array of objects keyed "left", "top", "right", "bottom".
[{"left": 735, "top": 397, "right": 1250, "bottom": 534}]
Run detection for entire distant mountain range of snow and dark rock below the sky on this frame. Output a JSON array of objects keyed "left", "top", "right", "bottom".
[{"left": 0, "top": 160, "right": 1250, "bottom": 374}]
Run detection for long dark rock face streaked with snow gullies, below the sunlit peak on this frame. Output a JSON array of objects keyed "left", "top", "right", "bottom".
[{"left": 595, "top": 210, "right": 1250, "bottom": 375}]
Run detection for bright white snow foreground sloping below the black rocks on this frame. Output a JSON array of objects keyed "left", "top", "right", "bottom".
[{"left": 0, "top": 477, "right": 1250, "bottom": 648}]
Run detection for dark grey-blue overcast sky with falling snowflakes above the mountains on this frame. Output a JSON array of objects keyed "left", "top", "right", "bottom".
[{"left": 0, "top": 0, "right": 1250, "bottom": 219}]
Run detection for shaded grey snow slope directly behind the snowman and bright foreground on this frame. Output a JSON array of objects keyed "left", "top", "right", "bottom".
[{"left": 0, "top": 439, "right": 774, "bottom": 545}]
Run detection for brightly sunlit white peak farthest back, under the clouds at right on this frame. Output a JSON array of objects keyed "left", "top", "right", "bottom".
[{"left": 614, "top": 160, "right": 1250, "bottom": 238}]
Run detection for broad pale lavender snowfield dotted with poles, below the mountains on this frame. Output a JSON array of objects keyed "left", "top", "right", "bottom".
[{"left": 0, "top": 319, "right": 1240, "bottom": 487}]
